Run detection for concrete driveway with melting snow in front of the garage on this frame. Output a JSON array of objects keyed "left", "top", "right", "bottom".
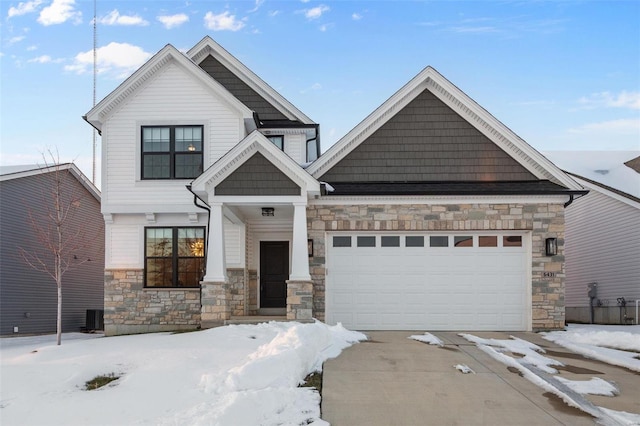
[{"left": 322, "top": 331, "right": 640, "bottom": 426}]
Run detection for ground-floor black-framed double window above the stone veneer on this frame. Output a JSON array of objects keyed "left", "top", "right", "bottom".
[{"left": 144, "top": 227, "right": 205, "bottom": 287}]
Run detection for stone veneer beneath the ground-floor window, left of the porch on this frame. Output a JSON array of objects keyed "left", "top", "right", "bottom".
[{"left": 104, "top": 269, "right": 200, "bottom": 336}]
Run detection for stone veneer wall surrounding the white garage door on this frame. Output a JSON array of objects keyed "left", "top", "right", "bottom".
[{"left": 307, "top": 203, "right": 565, "bottom": 330}]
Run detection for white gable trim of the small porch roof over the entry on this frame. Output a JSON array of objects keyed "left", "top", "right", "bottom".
[{"left": 191, "top": 130, "right": 320, "bottom": 201}]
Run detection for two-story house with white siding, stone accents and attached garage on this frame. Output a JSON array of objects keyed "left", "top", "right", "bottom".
[{"left": 85, "top": 37, "right": 584, "bottom": 334}]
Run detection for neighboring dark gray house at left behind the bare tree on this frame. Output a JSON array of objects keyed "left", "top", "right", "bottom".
[{"left": 0, "top": 164, "right": 104, "bottom": 335}]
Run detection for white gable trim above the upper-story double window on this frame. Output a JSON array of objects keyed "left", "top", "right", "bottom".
[{"left": 85, "top": 44, "right": 253, "bottom": 131}]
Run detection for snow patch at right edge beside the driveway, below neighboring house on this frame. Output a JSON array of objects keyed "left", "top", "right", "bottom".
[{"left": 541, "top": 324, "right": 640, "bottom": 372}]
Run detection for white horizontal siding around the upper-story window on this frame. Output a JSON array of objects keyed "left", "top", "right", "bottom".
[{"left": 102, "top": 64, "right": 244, "bottom": 212}]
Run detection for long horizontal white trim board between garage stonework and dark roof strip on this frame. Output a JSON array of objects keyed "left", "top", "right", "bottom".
[{"left": 309, "top": 195, "right": 570, "bottom": 206}]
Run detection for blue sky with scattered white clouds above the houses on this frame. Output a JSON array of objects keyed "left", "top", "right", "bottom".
[{"left": 0, "top": 0, "right": 640, "bottom": 186}]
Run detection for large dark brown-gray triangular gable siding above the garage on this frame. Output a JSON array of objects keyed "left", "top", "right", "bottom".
[{"left": 320, "top": 90, "right": 536, "bottom": 182}]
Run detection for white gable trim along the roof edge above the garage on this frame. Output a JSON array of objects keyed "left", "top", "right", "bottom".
[{"left": 307, "top": 67, "right": 581, "bottom": 190}]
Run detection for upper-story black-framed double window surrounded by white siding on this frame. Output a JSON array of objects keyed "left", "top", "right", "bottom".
[{"left": 142, "top": 126, "right": 203, "bottom": 179}]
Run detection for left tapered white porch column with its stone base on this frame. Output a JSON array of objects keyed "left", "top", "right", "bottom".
[{"left": 200, "top": 203, "right": 231, "bottom": 328}]
